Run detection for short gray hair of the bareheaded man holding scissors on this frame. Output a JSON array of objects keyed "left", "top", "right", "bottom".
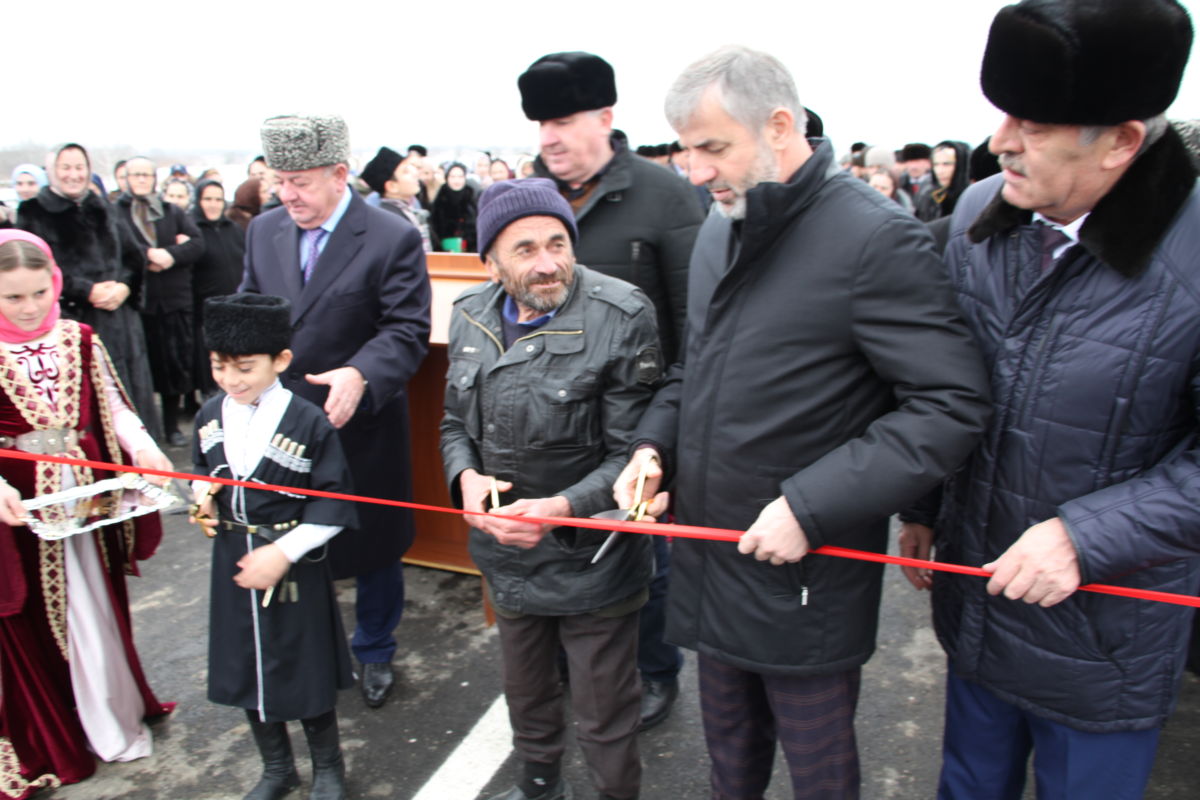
[{"left": 664, "top": 46, "right": 809, "bottom": 134}]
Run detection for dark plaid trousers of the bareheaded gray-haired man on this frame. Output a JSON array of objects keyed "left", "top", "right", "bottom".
[{"left": 697, "top": 654, "right": 862, "bottom": 800}]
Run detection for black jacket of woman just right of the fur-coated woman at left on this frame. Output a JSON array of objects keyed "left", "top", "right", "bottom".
[{"left": 116, "top": 194, "right": 204, "bottom": 314}]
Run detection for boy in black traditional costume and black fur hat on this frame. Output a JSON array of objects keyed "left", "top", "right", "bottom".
[{"left": 192, "top": 294, "right": 358, "bottom": 800}]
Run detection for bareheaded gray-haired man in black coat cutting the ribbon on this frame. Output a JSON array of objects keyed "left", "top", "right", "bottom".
[{"left": 614, "top": 48, "right": 988, "bottom": 800}]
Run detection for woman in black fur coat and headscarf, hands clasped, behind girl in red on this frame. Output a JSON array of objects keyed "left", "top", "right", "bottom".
[{"left": 17, "top": 143, "right": 162, "bottom": 440}]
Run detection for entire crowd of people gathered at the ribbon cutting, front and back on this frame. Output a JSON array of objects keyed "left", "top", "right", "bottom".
[{"left": 0, "top": 0, "right": 1200, "bottom": 800}]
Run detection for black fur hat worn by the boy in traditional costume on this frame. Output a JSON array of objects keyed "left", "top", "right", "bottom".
[{"left": 204, "top": 291, "right": 292, "bottom": 355}]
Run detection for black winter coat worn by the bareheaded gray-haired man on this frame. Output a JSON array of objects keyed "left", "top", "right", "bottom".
[{"left": 636, "top": 139, "right": 988, "bottom": 675}]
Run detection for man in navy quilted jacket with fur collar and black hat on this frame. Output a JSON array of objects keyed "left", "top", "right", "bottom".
[{"left": 901, "top": 0, "right": 1200, "bottom": 800}]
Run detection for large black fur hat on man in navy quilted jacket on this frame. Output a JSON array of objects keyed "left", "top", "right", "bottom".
[{"left": 980, "top": 0, "right": 1192, "bottom": 125}]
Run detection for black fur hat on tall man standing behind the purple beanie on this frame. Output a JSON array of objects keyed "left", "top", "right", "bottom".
[{"left": 517, "top": 53, "right": 617, "bottom": 122}]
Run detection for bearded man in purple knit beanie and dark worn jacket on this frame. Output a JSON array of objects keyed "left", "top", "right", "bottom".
[{"left": 442, "top": 178, "right": 662, "bottom": 800}]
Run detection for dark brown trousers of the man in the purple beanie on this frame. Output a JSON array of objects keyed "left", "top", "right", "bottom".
[{"left": 496, "top": 612, "right": 642, "bottom": 800}]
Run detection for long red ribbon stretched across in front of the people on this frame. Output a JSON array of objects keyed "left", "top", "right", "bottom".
[{"left": 0, "top": 450, "right": 1200, "bottom": 608}]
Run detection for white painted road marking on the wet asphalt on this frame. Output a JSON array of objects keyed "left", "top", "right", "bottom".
[{"left": 413, "top": 694, "right": 512, "bottom": 800}]
